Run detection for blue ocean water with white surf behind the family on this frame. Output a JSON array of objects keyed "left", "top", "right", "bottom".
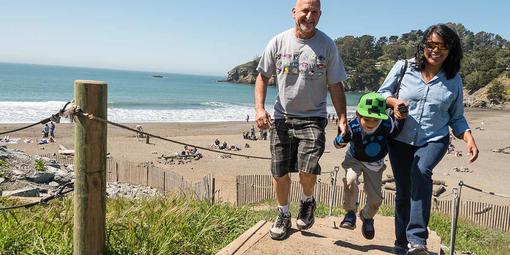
[{"left": 0, "top": 63, "right": 361, "bottom": 123}]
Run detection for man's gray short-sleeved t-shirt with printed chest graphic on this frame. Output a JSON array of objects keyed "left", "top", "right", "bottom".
[{"left": 257, "top": 28, "right": 347, "bottom": 119}]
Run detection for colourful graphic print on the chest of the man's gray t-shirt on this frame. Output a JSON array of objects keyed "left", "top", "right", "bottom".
[{"left": 276, "top": 52, "right": 327, "bottom": 80}]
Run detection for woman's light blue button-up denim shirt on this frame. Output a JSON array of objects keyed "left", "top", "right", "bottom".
[{"left": 378, "top": 59, "right": 469, "bottom": 146}]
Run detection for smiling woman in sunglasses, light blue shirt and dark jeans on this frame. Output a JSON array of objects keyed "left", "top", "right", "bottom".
[{"left": 378, "top": 24, "right": 478, "bottom": 254}]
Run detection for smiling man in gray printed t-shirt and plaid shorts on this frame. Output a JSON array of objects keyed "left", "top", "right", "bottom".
[{"left": 255, "top": 0, "right": 347, "bottom": 240}]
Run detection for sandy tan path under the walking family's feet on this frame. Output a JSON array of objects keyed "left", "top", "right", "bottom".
[{"left": 217, "top": 216, "right": 441, "bottom": 255}]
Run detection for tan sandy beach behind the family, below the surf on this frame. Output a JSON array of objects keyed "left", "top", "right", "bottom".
[{"left": 0, "top": 109, "right": 510, "bottom": 205}]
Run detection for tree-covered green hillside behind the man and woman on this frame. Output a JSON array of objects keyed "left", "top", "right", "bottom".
[{"left": 227, "top": 23, "right": 510, "bottom": 106}]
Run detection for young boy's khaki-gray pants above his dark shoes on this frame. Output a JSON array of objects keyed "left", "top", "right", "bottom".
[{"left": 342, "top": 153, "right": 386, "bottom": 219}]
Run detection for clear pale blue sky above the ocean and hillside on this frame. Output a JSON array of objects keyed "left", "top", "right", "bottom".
[{"left": 0, "top": 0, "right": 510, "bottom": 76}]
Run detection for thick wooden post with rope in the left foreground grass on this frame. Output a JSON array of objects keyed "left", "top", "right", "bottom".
[{"left": 73, "top": 80, "right": 107, "bottom": 255}]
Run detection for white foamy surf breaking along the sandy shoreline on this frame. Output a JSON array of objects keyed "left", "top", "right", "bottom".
[{"left": 0, "top": 101, "right": 354, "bottom": 123}]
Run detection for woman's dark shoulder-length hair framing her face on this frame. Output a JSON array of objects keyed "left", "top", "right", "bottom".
[{"left": 414, "top": 24, "right": 463, "bottom": 80}]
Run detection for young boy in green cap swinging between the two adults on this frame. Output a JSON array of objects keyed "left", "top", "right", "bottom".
[{"left": 334, "top": 93, "right": 404, "bottom": 239}]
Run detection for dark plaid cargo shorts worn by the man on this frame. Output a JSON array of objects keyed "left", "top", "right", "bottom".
[{"left": 270, "top": 117, "right": 328, "bottom": 177}]
